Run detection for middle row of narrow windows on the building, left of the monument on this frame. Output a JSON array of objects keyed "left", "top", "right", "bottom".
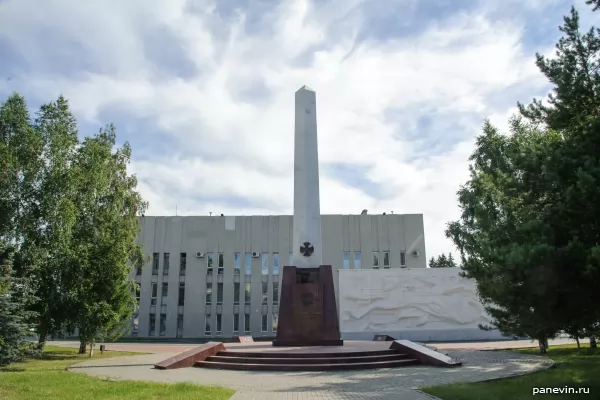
[{"left": 150, "top": 282, "right": 279, "bottom": 306}]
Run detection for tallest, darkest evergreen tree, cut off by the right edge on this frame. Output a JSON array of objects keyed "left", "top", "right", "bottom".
[{"left": 519, "top": 1, "right": 600, "bottom": 345}]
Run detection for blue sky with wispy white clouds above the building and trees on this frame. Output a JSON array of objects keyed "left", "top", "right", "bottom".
[{"left": 0, "top": 0, "right": 592, "bottom": 256}]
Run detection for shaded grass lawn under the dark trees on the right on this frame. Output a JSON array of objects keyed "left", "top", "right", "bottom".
[{"left": 421, "top": 345, "right": 600, "bottom": 400}]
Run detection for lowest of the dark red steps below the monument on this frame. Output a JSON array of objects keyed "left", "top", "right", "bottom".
[{"left": 194, "top": 358, "right": 420, "bottom": 371}]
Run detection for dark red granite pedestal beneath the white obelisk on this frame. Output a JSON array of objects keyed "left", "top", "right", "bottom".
[{"left": 273, "top": 265, "right": 344, "bottom": 346}]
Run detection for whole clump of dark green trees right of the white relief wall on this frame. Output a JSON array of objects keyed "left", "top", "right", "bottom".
[{"left": 446, "top": 4, "right": 600, "bottom": 352}]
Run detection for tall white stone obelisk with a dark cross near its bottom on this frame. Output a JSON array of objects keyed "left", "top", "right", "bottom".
[{"left": 292, "top": 86, "right": 323, "bottom": 268}]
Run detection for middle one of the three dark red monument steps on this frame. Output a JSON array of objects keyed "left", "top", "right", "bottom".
[{"left": 206, "top": 353, "right": 409, "bottom": 364}]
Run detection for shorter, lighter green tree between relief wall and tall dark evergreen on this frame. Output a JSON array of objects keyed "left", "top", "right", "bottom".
[{"left": 446, "top": 118, "right": 560, "bottom": 348}]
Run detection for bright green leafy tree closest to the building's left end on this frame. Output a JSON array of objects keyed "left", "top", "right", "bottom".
[{"left": 67, "top": 125, "right": 146, "bottom": 356}]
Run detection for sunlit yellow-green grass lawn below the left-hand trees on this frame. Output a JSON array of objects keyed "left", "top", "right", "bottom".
[{"left": 0, "top": 346, "right": 239, "bottom": 400}]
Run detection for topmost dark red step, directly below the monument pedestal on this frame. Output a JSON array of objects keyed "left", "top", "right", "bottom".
[{"left": 217, "top": 347, "right": 398, "bottom": 358}]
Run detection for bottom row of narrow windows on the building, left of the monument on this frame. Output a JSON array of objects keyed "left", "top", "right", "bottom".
[{"left": 145, "top": 313, "right": 279, "bottom": 338}]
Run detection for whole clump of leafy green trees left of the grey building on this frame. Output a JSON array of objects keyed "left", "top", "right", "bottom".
[{"left": 0, "top": 94, "right": 147, "bottom": 362}]
